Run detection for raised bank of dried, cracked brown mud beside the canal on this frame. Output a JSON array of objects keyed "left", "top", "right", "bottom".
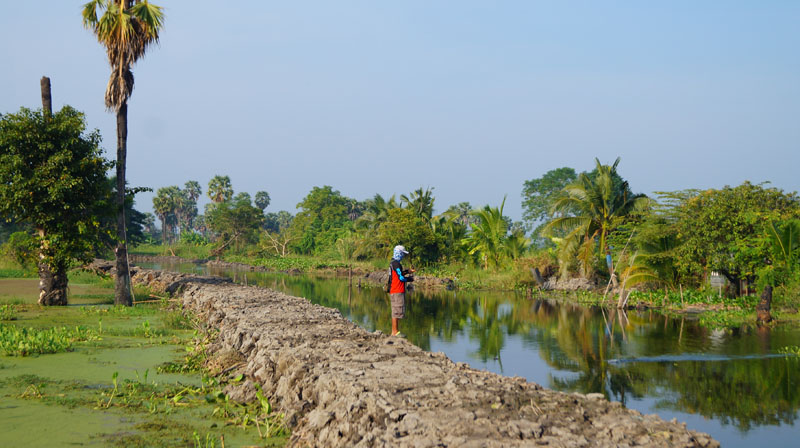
[{"left": 108, "top": 262, "right": 719, "bottom": 447}]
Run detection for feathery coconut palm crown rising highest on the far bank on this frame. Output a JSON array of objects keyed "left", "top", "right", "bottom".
[{"left": 543, "top": 157, "right": 650, "bottom": 274}]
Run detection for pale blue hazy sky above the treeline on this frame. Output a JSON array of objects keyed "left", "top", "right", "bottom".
[{"left": 0, "top": 0, "right": 800, "bottom": 219}]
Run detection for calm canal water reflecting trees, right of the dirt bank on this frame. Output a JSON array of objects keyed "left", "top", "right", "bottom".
[{"left": 140, "top": 263, "right": 800, "bottom": 447}]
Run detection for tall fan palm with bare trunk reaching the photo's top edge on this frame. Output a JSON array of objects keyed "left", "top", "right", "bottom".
[{"left": 82, "top": 0, "right": 164, "bottom": 306}]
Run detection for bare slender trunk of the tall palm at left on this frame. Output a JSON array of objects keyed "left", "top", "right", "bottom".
[{"left": 114, "top": 102, "right": 133, "bottom": 306}]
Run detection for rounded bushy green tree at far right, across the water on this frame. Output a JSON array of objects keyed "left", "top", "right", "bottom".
[{"left": 665, "top": 182, "right": 800, "bottom": 293}]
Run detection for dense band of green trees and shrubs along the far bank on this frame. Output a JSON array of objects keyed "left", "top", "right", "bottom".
[{"left": 115, "top": 159, "right": 800, "bottom": 312}]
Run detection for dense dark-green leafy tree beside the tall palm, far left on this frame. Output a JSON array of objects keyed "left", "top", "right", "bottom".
[{"left": 0, "top": 106, "right": 113, "bottom": 305}]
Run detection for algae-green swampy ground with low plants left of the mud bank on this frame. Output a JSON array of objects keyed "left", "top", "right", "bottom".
[{"left": 0, "top": 270, "right": 288, "bottom": 447}]
